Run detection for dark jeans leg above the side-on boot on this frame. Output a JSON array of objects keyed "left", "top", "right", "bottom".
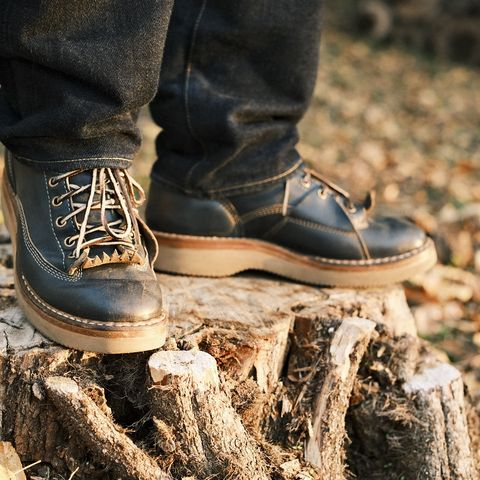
[{"left": 151, "top": 0, "right": 321, "bottom": 194}]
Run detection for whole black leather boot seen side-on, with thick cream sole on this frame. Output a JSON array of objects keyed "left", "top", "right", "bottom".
[{"left": 146, "top": 167, "right": 437, "bottom": 287}]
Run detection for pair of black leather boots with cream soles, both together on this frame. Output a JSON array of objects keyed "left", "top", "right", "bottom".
[{"left": 2, "top": 152, "right": 436, "bottom": 353}]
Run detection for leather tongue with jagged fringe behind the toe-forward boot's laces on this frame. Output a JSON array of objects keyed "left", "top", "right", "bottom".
[{"left": 69, "top": 170, "right": 145, "bottom": 269}]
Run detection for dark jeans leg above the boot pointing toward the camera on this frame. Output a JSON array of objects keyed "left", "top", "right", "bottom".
[{"left": 0, "top": 0, "right": 173, "bottom": 170}]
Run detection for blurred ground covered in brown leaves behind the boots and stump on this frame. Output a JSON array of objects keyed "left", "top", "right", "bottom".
[{"left": 2, "top": 31, "right": 480, "bottom": 394}]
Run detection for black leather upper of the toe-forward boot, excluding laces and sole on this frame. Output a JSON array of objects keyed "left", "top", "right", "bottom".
[{"left": 6, "top": 154, "right": 163, "bottom": 328}]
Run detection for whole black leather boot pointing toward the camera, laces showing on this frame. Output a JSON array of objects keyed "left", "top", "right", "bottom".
[{"left": 2, "top": 152, "right": 168, "bottom": 353}]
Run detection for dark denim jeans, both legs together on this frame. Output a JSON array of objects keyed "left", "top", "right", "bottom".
[{"left": 0, "top": 0, "right": 321, "bottom": 194}]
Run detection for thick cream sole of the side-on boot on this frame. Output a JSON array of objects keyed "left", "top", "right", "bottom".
[{"left": 153, "top": 231, "right": 437, "bottom": 288}]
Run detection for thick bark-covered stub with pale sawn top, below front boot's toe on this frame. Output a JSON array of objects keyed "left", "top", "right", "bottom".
[{"left": 148, "top": 351, "right": 270, "bottom": 480}]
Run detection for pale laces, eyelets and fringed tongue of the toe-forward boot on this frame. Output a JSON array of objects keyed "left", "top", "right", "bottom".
[{"left": 49, "top": 168, "right": 145, "bottom": 275}]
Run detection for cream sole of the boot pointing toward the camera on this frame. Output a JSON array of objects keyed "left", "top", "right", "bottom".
[{"left": 1, "top": 174, "right": 168, "bottom": 354}]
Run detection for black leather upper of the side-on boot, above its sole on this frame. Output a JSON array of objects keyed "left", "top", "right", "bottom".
[{"left": 146, "top": 167, "right": 426, "bottom": 260}]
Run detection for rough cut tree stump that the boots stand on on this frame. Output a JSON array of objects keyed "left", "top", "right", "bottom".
[{"left": 0, "top": 246, "right": 480, "bottom": 480}]
